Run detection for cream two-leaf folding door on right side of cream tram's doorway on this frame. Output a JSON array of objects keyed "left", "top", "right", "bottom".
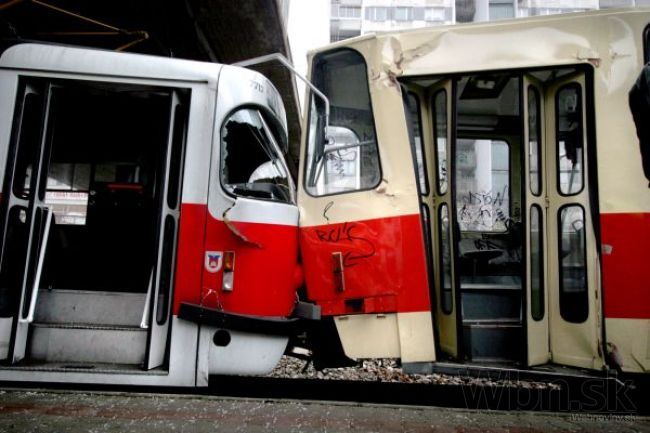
[{"left": 523, "top": 71, "right": 604, "bottom": 368}]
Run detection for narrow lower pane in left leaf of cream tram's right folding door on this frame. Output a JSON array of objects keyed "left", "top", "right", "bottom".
[{"left": 530, "top": 205, "right": 544, "bottom": 320}]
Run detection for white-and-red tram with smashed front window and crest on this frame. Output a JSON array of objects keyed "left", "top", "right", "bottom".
[{"left": 0, "top": 44, "right": 299, "bottom": 386}]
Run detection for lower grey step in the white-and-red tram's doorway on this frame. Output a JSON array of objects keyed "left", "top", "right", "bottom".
[{"left": 28, "top": 323, "right": 147, "bottom": 364}]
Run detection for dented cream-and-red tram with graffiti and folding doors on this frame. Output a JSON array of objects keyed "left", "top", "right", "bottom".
[{"left": 298, "top": 10, "right": 650, "bottom": 372}]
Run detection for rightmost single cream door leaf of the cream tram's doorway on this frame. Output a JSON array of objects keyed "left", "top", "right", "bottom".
[{"left": 531, "top": 72, "right": 604, "bottom": 368}]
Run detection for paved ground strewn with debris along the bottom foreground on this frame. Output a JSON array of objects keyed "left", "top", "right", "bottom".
[{"left": 0, "top": 388, "right": 650, "bottom": 433}]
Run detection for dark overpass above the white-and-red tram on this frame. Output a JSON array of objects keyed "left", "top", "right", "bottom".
[{"left": 0, "top": 0, "right": 300, "bottom": 169}]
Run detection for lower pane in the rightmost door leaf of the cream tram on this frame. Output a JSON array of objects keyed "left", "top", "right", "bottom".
[{"left": 558, "top": 205, "right": 589, "bottom": 323}]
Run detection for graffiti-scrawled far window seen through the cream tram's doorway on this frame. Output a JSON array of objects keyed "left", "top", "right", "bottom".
[{"left": 456, "top": 139, "right": 511, "bottom": 232}]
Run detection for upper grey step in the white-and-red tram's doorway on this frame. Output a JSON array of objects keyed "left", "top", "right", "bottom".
[{"left": 35, "top": 289, "right": 146, "bottom": 326}]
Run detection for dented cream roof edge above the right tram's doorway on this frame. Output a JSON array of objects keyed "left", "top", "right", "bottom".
[{"left": 309, "top": 8, "right": 650, "bottom": 78}]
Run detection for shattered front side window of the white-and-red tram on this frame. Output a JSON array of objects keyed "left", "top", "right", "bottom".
[{"left": 221, "top": 108, "right": 294, "bottom": 203}]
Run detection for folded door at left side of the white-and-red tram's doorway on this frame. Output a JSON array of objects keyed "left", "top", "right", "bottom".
[{"left": 0, "top": 84, "right": 52, "bottom": 363}]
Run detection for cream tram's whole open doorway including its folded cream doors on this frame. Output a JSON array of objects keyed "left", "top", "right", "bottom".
[{"left": 403, "top": 67, "right": 603, "bottom": 368}]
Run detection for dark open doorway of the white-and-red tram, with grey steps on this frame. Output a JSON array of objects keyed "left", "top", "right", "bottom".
[{"left": 0, "top": 78, "right": 188, "bottom": 369}]
